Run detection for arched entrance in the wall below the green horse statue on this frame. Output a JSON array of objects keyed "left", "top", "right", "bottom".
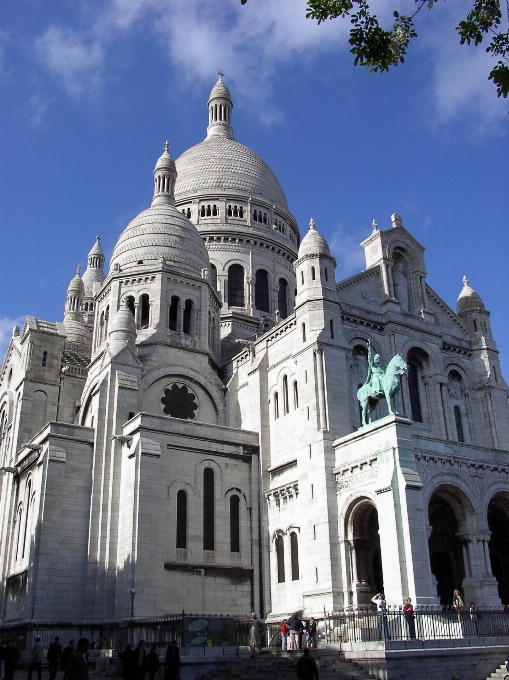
[{"left": 348, "top": 498, "right": 384, "bottom": 604}]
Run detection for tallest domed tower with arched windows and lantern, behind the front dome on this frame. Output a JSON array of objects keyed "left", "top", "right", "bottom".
[{"left": 175, "top": 72, "right": 300, "bottom": 361}]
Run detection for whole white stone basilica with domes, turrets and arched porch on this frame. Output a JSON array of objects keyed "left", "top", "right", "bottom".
[{"left": 0, "top": 76, "right": 509, "bottom": 623}]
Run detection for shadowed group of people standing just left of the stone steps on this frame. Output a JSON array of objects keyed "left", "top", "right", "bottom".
[{"left": 118, "top": 640, "right": 181, "bottom": 680}]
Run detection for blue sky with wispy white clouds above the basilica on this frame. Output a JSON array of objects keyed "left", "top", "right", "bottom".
[{"left": 0, "top": 0, "right": 509, "bottom": 377}]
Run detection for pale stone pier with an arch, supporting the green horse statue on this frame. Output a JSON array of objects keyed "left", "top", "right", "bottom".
[{"left": 334, "top": 416, "right": 439, "bottom": 605}]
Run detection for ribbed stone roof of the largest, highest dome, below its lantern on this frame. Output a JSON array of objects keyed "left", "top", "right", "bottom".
[{"left": 175, "top": 136, "right": 288, "bottom": 211}]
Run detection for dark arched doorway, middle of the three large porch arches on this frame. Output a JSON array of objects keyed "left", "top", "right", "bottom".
[{"left": 428, "top": 485, "right": 468, "bottom": 605}]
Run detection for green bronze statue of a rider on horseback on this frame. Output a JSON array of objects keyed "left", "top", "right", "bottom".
[{"left": 357, "top": 341, "right": 408, "bottom": 427}]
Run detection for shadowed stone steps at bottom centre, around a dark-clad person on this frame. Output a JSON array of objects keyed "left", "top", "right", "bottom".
[{"left": 196, "top": 649, "right": 374, "bottom": 680}]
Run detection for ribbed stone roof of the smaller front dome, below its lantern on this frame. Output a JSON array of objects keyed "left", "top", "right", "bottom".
[{"left": 110, "top": 203, "right": 210, "bottom": 276}]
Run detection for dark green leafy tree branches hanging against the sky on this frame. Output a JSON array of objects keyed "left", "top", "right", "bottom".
[{"left": 241, "top": 0, "right": 509, "bottom": 97}]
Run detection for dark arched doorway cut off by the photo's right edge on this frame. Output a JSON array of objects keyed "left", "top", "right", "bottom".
[{"left": 488, "top": 493, "right": 509, "bottom": 604}]
